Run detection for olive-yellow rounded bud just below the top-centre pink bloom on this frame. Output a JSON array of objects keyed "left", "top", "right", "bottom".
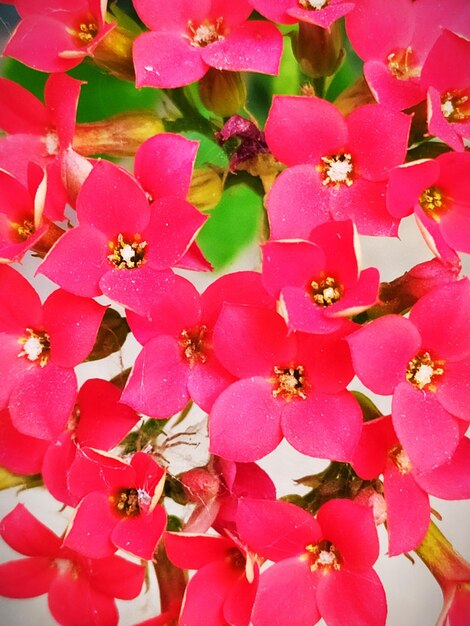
[{"left": 199, "top": 67, "right": 246, "bottom": 117}]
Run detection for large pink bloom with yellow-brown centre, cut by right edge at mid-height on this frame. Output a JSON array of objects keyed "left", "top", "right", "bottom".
[{"left": 347, "top": 279, "right": 470, "bottom": 472}]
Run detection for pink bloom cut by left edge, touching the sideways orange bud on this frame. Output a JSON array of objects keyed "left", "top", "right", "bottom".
[{"left": 0, "top": 74, "right": 81, "bottom": 220}]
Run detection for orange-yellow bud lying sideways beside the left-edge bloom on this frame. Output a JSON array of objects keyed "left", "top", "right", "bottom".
[{"left": 72, "top": 111, "right": 164, "bottom": 157}]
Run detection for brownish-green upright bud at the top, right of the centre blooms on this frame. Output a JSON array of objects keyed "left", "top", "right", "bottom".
[{"left": 292, "top": 22, "right": 345, "bottom": 78}]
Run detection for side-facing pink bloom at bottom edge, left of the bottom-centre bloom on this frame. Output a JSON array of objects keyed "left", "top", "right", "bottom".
[{"left": 164, "top": 533, "right": 259, "bottom": 626}]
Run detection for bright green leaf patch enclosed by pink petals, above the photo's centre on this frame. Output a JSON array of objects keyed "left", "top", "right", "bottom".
[{"left": 198, "top": 183, "right": 263, "bottom": 268}]
